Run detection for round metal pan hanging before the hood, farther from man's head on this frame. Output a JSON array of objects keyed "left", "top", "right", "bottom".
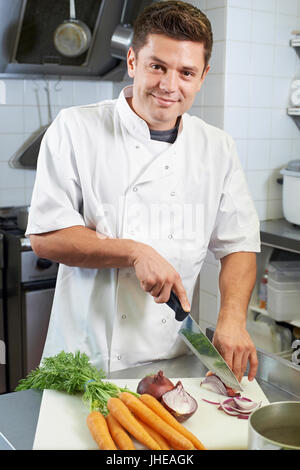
[{"left": 54, "top": 0, "right": 92, "bottom": 57}]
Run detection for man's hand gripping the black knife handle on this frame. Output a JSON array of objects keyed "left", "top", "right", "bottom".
[{"left": 133, "top": 243, "right": 191, "bottom": 312}]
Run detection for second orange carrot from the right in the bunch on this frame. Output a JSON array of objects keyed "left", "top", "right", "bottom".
[{"left": 119, "top": 392, "right": 194, "bottom": 450}]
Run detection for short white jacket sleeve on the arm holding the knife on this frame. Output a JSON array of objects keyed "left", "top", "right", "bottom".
[{"left": 25, "top": 111, "right": 85, "bottom": 237}]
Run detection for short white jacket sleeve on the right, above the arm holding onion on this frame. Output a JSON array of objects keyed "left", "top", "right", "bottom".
[{"left": 208, "top": 141, "right": 260, "bottom": 259}]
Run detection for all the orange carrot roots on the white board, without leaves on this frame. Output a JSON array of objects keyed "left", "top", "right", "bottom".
[{"left": 87, "top": 392, "right": 205, "bottom": 450}]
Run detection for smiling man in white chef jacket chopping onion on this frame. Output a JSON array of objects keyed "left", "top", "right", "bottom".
[{"left": 26, "top": 1, "right": 260, "bottom": 380}]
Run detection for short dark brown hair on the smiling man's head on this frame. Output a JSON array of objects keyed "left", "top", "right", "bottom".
[{"left": 132, "top": 0, "right": 213, "bottom": 66}]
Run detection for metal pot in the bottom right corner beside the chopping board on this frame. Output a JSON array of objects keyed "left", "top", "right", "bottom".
[{"left": 248, "top": 401, "right": 300, "bottom": 450}]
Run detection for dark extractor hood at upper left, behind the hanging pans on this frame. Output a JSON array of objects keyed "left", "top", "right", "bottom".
[{"left": 0, "top": 0, "right": 152, "bottom": 81}]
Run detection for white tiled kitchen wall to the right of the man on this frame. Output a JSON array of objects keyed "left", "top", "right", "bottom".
[{"left": 191, "top": 0, "right": 300, "bottom": 328}]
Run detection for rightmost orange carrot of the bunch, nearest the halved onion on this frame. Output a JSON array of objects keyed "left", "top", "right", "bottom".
[{"left": 139, "top": 393, "right": 205, "bottom": 450}]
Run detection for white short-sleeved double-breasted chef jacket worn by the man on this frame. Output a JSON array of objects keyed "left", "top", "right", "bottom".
[{"left": 26, "top": 86, "right": 260, "bottom": 371}]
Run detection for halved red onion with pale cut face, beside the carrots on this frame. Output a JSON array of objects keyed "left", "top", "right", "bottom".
[{"left": 161, "top": 381, "right": 198, "bottom": 423}]
